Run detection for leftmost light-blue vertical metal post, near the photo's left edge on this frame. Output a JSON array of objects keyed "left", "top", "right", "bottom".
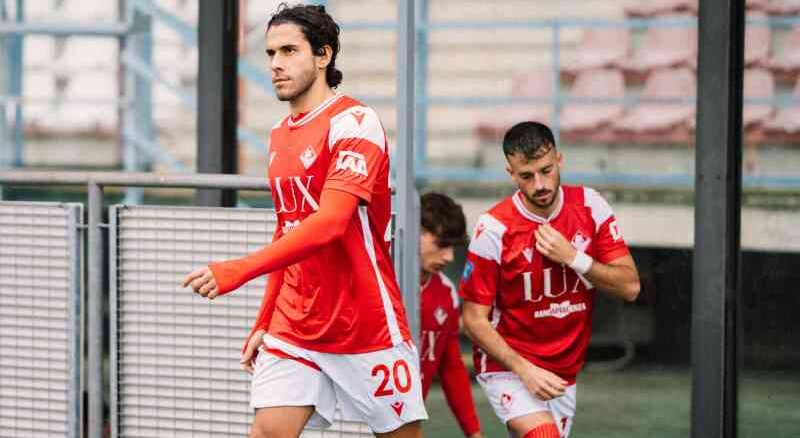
[{"left": 8, "top": 0, "right": 25, "bottom": 167}]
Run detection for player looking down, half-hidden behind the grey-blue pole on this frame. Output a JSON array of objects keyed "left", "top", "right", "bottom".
[{"left": 419, "top": 193, "right": 481, "bottom": 438}]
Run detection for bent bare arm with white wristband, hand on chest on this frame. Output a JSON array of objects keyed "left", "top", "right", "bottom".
[{"left": 536, "top": 224, "right": 641, "bottom": 301}]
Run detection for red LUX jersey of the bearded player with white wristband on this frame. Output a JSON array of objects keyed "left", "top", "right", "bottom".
[{"left": 460, "top": 185, "right": 629, "bottom": 382}]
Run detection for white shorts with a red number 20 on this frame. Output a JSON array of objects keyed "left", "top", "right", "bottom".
[{"left": 250, "top": 335, "right": 428, "bottom": 433}]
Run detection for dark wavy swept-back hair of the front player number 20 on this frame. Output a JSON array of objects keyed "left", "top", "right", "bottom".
[{"left": 267, "top": 3, "right": 342, "bottom": 88}]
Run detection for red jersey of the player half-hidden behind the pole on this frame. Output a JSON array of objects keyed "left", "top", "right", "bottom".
[{"left": 420, "top": 273, "right": 481, "bottom": 436}]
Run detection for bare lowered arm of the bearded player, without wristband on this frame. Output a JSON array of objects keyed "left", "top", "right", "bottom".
[{"left": 464, "top": 300, "right": 567, "bottom": 400}]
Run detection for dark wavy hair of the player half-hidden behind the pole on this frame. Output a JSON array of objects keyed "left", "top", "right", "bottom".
[{"left": 420, "top": 192, "right": 467, "bottom": 247}]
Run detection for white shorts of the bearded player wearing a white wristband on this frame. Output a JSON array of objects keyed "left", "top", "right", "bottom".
[{"left": 478, "top": 371, "right": 577, "bottom": 438}]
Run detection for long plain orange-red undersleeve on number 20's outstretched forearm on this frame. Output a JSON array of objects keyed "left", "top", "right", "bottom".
[{"left": 209, "top": 190, "right": 358, "bottom": 294}]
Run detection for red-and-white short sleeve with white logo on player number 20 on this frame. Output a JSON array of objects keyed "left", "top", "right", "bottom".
[{"left": 324, "top": 106, "right": 388, "bottom": 203}]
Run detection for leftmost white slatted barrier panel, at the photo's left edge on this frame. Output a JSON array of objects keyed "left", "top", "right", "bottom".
[{"left": 0, "top": 202, "right": 83, "bottom": 438}]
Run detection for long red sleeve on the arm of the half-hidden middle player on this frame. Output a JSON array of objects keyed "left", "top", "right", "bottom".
[{"left": 439, "top": 326, "right": 481, "bottom": 436}]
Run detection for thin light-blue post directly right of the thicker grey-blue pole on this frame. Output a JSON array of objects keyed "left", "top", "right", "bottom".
[{"left": 414, "top": 0, "right": 429, "bottom": 178}]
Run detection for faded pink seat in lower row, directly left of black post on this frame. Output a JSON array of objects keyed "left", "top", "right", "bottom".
[{"left": 612, "top": 68, "right": 697, "bottom": 142}]
